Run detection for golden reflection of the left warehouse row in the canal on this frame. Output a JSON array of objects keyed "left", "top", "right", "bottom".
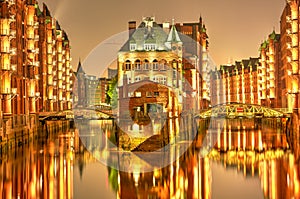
[{"left": 0, "top": 122, "right": 74, "bottom": 199}]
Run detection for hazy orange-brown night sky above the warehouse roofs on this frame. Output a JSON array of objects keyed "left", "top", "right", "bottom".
[{"left": 39, "top": 0, "right": 285, "bottom": 72}]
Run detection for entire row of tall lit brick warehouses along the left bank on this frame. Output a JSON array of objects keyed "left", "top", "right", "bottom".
[{"left": 0, "top": 0, "right": 73, "bottom": 134}]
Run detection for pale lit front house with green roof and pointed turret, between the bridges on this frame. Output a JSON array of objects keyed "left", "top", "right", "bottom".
[{"left": 118, "top": 17, "right": 183, "bottom": 117}]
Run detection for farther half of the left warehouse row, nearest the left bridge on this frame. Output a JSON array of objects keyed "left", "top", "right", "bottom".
[{"left": 36, "top": 4, "right": 73, "bottom": 112}]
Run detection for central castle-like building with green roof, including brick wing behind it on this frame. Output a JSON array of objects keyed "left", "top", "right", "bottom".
[{"left": 118, "top": 17, "right": 209, "bottom": 117}]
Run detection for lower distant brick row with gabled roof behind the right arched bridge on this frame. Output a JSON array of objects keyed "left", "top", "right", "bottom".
[{"left": 210, "top": 58, "right": 259, "bottom": 106}]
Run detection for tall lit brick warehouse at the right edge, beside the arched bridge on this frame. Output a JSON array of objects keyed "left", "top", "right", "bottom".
[{"left": 211, "top": 0, "right": 300, "bottom": 113}]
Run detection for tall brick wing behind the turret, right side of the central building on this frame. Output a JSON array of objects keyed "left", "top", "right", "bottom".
[{"left": 176, "top": 17, "right": 211, "bottom": 109}]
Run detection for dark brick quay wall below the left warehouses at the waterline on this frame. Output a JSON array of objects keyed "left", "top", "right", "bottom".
[{"left": 0, "top": 114, "right": 70, "bottom": 153}]
